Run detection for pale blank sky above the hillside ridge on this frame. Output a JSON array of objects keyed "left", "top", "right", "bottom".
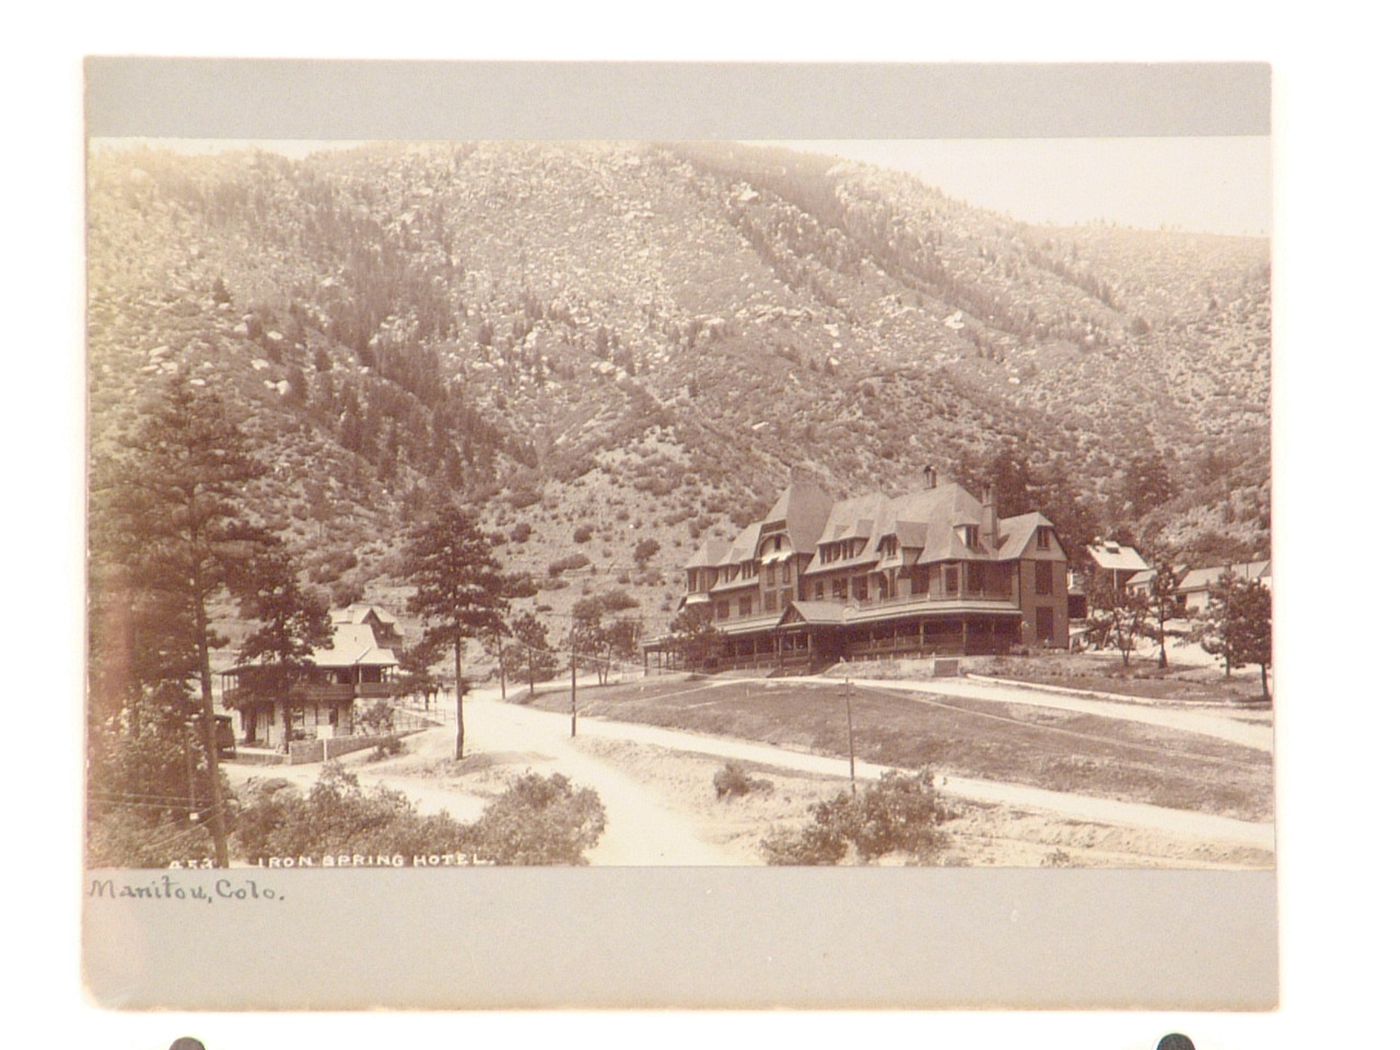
[{"left": 94, "top": 136, "right": 1271, "bottom": 237}]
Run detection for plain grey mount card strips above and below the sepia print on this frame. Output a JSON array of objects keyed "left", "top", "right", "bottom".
[{"left": 84, "top": 57, "right": 1278, "bottom": 1009}]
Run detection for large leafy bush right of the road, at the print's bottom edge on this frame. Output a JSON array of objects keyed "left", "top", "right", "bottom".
[{"left": 760, "top": 767, "right": 956, "bottom": 865}]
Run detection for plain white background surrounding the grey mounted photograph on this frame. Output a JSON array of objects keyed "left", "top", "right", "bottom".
[{"left": 0, "top": 1, "right": 1400, "bottom": 1050}]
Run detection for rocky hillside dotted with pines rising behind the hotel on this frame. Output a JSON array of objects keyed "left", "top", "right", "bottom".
[{"left": 88, "top": 143, "right": 1270, "bottom": 649}]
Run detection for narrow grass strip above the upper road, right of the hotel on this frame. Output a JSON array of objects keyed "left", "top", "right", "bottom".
[{"left": 976, "top": 654, "right": 1263, "bottom": 704}]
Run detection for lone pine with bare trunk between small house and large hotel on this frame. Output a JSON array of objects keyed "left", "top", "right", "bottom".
[{"left": 405, "top": 504, "right": 507, "bottom": 759}]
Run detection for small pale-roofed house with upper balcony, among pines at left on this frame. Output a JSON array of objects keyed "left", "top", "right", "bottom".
[{"left": 221, "top": 605, "right": 403, "bottom": 750}]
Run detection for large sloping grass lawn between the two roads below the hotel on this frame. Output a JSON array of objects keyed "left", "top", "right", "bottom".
[{"left": 520, "top": 680, "right": 1273, "bottom": 820}]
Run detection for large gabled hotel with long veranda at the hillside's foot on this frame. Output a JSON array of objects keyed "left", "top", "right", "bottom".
[{"left": 643, "top": 469, "right": 1070, "bottom": 672}]
